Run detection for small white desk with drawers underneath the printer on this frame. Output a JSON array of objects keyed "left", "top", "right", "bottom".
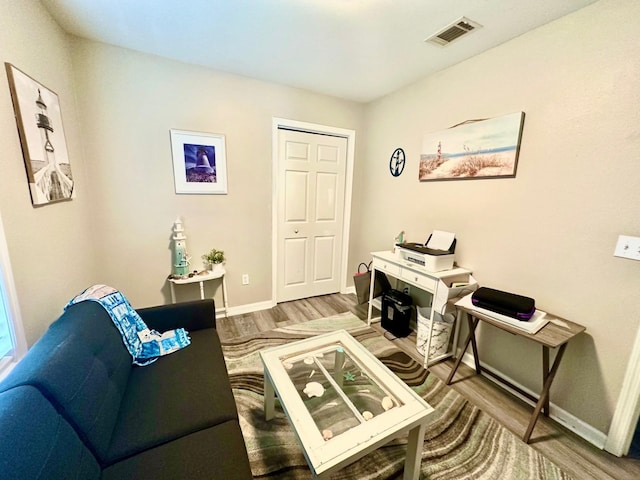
[{"left": 367, "top": 251, "right": 473, "bottom": 366}]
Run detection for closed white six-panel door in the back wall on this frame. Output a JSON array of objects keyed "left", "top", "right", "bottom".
[{"left": 276, "top": 130, "right": 347, "bottom": 302}]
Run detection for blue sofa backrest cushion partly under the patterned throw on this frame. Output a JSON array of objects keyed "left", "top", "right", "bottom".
[{"left": 0, "top": 302, "right": 132, "bottom": 463}]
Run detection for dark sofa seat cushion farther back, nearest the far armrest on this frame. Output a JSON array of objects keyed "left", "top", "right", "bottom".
[{"left": 107, "top": 328, "right": 239, "bottom": 462}]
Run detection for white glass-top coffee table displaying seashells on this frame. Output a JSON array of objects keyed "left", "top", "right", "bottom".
[{"left": 260, "top": 330, "right": 433, "bottom": 479}]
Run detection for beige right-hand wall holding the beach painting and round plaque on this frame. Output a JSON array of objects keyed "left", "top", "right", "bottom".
[{"left": 352, "top": 0, "right": 640, "bottom": 433}]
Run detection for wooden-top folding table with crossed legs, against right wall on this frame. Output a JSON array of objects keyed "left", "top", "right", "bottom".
[{"left": 445, "top": 305, "right": 586, "bottom": 443}]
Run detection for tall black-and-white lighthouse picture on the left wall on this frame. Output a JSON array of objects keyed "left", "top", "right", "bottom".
[{"left": 4, "top": 63, "right": 74, "bottom": 206}]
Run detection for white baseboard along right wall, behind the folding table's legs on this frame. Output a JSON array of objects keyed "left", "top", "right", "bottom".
[{"left": 462, "top": 353, "right": 607, "bottom": 449}]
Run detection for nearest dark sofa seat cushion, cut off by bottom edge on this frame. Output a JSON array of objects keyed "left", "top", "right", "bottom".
[{"left": 102, "top": 420, "right": 253, "bottom": 480}]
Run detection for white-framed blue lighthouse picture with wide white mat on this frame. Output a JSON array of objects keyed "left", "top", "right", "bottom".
[{"left": 170, "top": 129, "right": 227, "bottom": 195}]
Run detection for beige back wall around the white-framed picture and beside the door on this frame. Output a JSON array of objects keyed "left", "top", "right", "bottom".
[{"left": 73, "top": 38, "right": 364, "bottom": 307}]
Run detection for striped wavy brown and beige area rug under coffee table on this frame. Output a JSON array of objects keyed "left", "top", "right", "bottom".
[{"left": 222, "top": 313, "right": 571, "bottom": 480}]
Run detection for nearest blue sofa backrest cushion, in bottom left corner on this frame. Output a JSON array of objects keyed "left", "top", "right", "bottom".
[{"left": 0, "top": 386, "right": 100, "bottom": 480}]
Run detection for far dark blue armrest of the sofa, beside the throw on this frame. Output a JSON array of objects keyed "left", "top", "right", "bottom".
[{"left": 136, "top": 299, "right": 216, "bottom": 332}]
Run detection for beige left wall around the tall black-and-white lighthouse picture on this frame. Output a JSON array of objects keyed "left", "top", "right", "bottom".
[{"left": 0, "top": 0, "right": 95, "bottom": 344}]
